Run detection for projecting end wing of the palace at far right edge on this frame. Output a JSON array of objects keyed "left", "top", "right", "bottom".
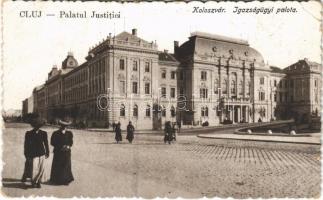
[{"left": 284, "top": 59, "right": 322, "bottom": 121}]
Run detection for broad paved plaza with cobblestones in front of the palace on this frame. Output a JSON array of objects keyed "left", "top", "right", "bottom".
[{"left": 2, "top": 124, "right": 321, "bottom": 198}]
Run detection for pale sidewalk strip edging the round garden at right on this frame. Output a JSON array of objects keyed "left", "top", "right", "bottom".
[{"left": 197, "top": 133, "right": 321, "bottom": 145}]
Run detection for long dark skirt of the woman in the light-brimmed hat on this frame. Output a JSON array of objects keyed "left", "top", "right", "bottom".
[{"left": 50, "top": 150, "right": 74, "bottom": 185}]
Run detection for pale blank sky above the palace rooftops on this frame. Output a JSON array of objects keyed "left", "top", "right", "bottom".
[{"left": 2, "top": 1, "right": 321, "bottom": 110}]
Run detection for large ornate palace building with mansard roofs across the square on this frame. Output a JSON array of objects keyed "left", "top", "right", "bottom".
[{"left": 23, "top": 29, "right": 321, "bottom": 129}]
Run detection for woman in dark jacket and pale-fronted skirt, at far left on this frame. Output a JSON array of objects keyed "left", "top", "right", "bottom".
[{"left": 21, "top": 118, "right": 49, "bottom": 188}]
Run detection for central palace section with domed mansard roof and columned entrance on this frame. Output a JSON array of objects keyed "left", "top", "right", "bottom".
[{"left": 174, "top": 32, "right": 270, "bottom": 125}]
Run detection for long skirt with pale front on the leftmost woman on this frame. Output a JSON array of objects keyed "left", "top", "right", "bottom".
[{"left": 23, "top": 155, "right": 47, "bottom": 183}]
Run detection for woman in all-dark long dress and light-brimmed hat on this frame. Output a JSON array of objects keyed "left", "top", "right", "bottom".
[{"left": 50, "top": 120, "right": 74, "bottom": 185}]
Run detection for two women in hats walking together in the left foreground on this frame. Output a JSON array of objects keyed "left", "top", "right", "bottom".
[{"left": 21, "top": 118, "right": 74, "bottom": 188}]
